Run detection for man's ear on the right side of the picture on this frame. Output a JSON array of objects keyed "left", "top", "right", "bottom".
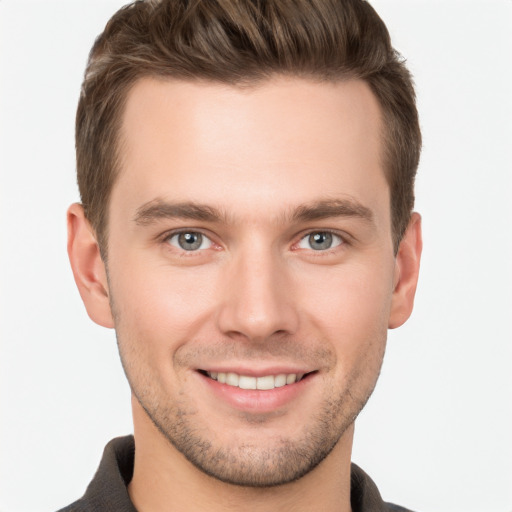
[{"left": 388, "top": 212, "right": 423, "bottom": 329}]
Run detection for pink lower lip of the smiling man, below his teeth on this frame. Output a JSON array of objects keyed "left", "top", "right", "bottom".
[{"left": 197, "top": 372, "right": 314, "bottom": 413}]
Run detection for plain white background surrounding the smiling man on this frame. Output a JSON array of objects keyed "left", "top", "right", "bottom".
[{"left": 0, "top": 0, "right": 512, "bottom": 512}]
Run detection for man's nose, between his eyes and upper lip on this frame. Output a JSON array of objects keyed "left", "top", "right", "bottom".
[{"left": 217, "top": 245, "right": 299, "bottom": 342}]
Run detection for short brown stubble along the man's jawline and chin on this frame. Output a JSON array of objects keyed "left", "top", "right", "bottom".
[{"left": 118, "top": 339, "right": 382, "bottom": 488}]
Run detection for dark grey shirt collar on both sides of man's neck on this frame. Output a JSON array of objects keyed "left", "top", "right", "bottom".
[{"left": 59, "top": 436, "right": 411, "bottom": 512}]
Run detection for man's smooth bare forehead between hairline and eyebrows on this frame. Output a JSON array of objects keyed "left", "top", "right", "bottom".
[{"left": 111, "top": 78, "right": 389, "bottom": 226}]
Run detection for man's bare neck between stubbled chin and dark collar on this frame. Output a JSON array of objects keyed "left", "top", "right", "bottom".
[{"left": 128, "top": 399, "right": 353, "bottom": 512}]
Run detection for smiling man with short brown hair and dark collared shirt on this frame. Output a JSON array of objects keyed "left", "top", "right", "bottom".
[{"left": 64, "top": 0, "right": 421, "bottom": 512}]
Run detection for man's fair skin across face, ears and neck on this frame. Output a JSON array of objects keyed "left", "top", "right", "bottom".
[{"left": 68, "top": 78, "right": 421, "bottom": 512}]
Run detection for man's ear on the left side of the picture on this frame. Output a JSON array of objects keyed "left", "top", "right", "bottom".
[{"left": 67, "top": 203, "right": 114, "bottom": 327}]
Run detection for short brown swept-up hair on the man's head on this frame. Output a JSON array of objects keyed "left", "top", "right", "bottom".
[{"left": 76, "top": 0, "right": 421, "bottom": 257}]
